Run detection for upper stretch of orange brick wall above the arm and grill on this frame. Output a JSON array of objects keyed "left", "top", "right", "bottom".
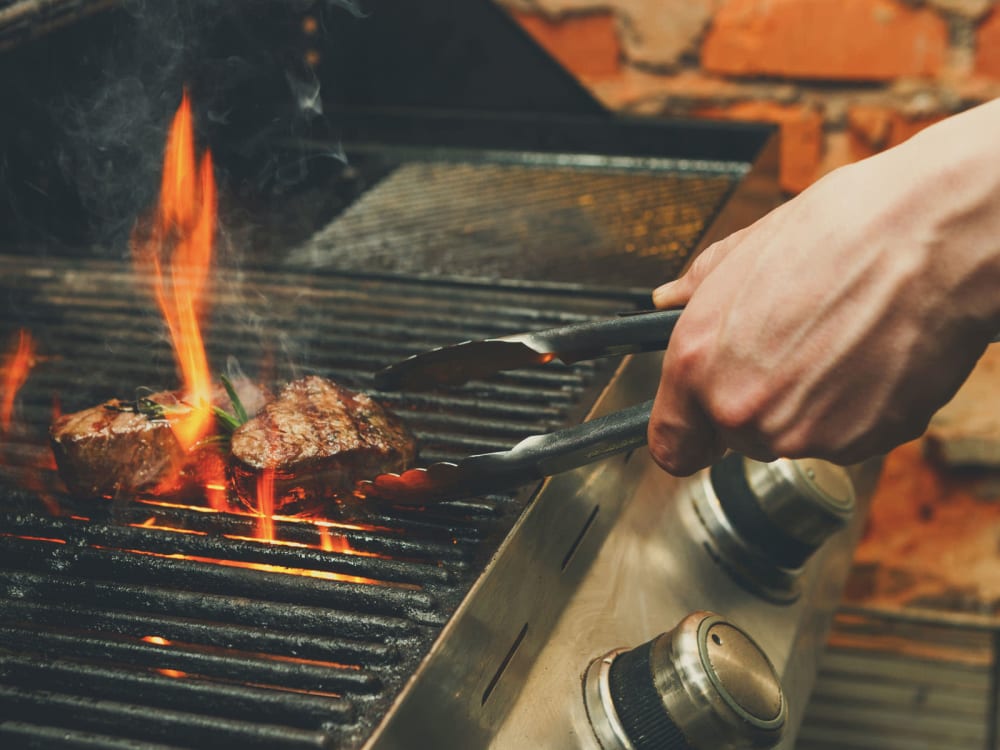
[{"left": 497, "top": 0, "right": 1000, "bottom": 192}]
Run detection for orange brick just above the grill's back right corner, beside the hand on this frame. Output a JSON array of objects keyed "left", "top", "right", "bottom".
[{"left": 694, "top": 102, "right": 823, "bottom": 193}]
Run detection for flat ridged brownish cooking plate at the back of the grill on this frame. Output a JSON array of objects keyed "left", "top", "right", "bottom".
[{"left": 291, "top": 159, "right": 745, "bottom": 289}]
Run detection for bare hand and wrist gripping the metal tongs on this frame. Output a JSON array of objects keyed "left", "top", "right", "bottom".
[{"left": 649, "top": 100, "right": 1000, "bottom": 475}]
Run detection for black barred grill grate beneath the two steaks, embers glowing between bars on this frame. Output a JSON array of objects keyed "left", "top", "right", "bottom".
[{"left": 0, "top": 256, "right": 634, "bottom": 748}]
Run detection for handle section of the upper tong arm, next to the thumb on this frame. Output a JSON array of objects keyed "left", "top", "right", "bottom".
[{"left": 508, "top": 310, "right": 682, "bottom": 365}]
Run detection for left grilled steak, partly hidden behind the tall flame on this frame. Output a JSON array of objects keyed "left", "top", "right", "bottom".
[{"left": 49, "top": 379, "right": 269, "bottom": 497}]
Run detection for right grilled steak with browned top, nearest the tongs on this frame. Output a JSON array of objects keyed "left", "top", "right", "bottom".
[{"left": 232, "top": 376, "right": 416, "bottom": 500}]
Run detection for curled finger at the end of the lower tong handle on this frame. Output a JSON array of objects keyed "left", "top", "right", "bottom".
[{"left": 648, "top": 364, "right": 725, "bottom": 476}]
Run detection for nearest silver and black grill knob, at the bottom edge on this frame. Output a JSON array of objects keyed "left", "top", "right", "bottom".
[{"left": 584, "top": 612, "right": 787, "bottom": 750}]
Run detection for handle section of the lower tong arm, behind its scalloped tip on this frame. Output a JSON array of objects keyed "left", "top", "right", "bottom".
[{"left": 459, "top": 399, "right": 653, "bottom": 491}]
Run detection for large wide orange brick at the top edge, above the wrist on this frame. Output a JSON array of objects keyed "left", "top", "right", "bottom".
[{"left": 701, "top": 0, "right": 948, "bottom": 81}]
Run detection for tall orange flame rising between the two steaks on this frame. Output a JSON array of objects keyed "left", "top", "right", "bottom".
[{"left": 133, "top": 92, "right": 217, "bottom": 450}]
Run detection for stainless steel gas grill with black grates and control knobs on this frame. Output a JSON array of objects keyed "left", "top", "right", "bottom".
[{"left": 0, "top": 0, "right": 872, "bottom": 750}]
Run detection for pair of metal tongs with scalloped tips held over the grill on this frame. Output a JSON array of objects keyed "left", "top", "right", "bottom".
[{"left": 357, "top": 310, "right": 681, "bottom": 505}]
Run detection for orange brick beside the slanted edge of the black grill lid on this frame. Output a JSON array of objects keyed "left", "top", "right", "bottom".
[{"left": 513, "top": 12, "right": 622, "bottom": 80}]
